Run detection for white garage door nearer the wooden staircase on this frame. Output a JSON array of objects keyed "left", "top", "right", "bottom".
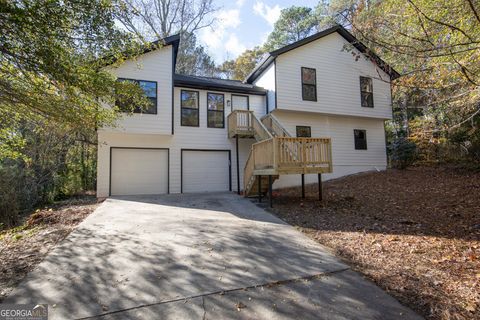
[{"left": 182, "top": 150, "right": 230, "bottom": 192}]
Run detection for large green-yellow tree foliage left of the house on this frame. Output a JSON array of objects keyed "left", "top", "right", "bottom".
[{"left": 0, "top": 0, "right": 148, "bottom": 228}]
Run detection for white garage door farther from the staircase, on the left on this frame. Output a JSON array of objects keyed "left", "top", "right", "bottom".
[{"left": 110, "top": 148, "right": 168, "bottom": 196}]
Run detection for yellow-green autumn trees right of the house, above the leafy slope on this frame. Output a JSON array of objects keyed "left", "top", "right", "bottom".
[{"left": 342, "top": 0, "right": 480, "bottom": 157}]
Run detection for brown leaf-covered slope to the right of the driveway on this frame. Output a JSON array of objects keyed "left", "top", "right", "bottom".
[{"left": 272, "top": 167, "right": 480, "bottom": 319}]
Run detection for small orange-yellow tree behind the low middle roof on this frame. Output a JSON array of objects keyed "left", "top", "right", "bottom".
[{"left": 219, "top": 46, "right": 265, "bottom": 80}]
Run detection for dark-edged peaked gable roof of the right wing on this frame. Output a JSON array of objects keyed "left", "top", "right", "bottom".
[{"left": 245, "top": 25, "right": 400, "bottom": 83}]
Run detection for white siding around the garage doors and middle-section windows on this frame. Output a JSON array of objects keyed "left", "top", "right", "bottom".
[{"left": 97, "top": 87, "right": 265, "bottom": 197}]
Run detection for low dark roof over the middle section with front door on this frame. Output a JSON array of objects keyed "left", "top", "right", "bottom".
[{"left": 173, "top": 74, "right": 267, "bottom": 95}]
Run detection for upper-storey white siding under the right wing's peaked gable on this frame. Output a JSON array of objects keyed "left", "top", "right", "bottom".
[{"left": 276, "top": 32, "right": 392, "bottom": 119}]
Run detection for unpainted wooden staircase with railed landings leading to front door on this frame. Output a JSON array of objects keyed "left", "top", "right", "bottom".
[{"left": 228, "top": 110, "right": 332, "bottom": 196}]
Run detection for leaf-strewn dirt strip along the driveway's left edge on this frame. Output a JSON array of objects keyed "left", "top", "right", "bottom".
[{"left": 0, "top": 196, "right": 98, "bottom": 303}]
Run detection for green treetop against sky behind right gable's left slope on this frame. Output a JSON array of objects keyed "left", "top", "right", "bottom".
[{"left": 264, "top": 6, "right": 318, "bottom": 51}]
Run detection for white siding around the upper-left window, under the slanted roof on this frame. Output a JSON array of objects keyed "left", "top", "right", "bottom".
[{"left": 102, "top": 46, "right": 173, "bottom": 134}]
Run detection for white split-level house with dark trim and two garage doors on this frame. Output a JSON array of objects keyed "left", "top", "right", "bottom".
[{"left": 97, "top": 26, "right": 399, "bottom": 197}]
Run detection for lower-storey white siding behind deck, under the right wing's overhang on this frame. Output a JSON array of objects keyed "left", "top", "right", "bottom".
[{"left": 274, "top": 110, "right": 387, "bottom": 188}]
